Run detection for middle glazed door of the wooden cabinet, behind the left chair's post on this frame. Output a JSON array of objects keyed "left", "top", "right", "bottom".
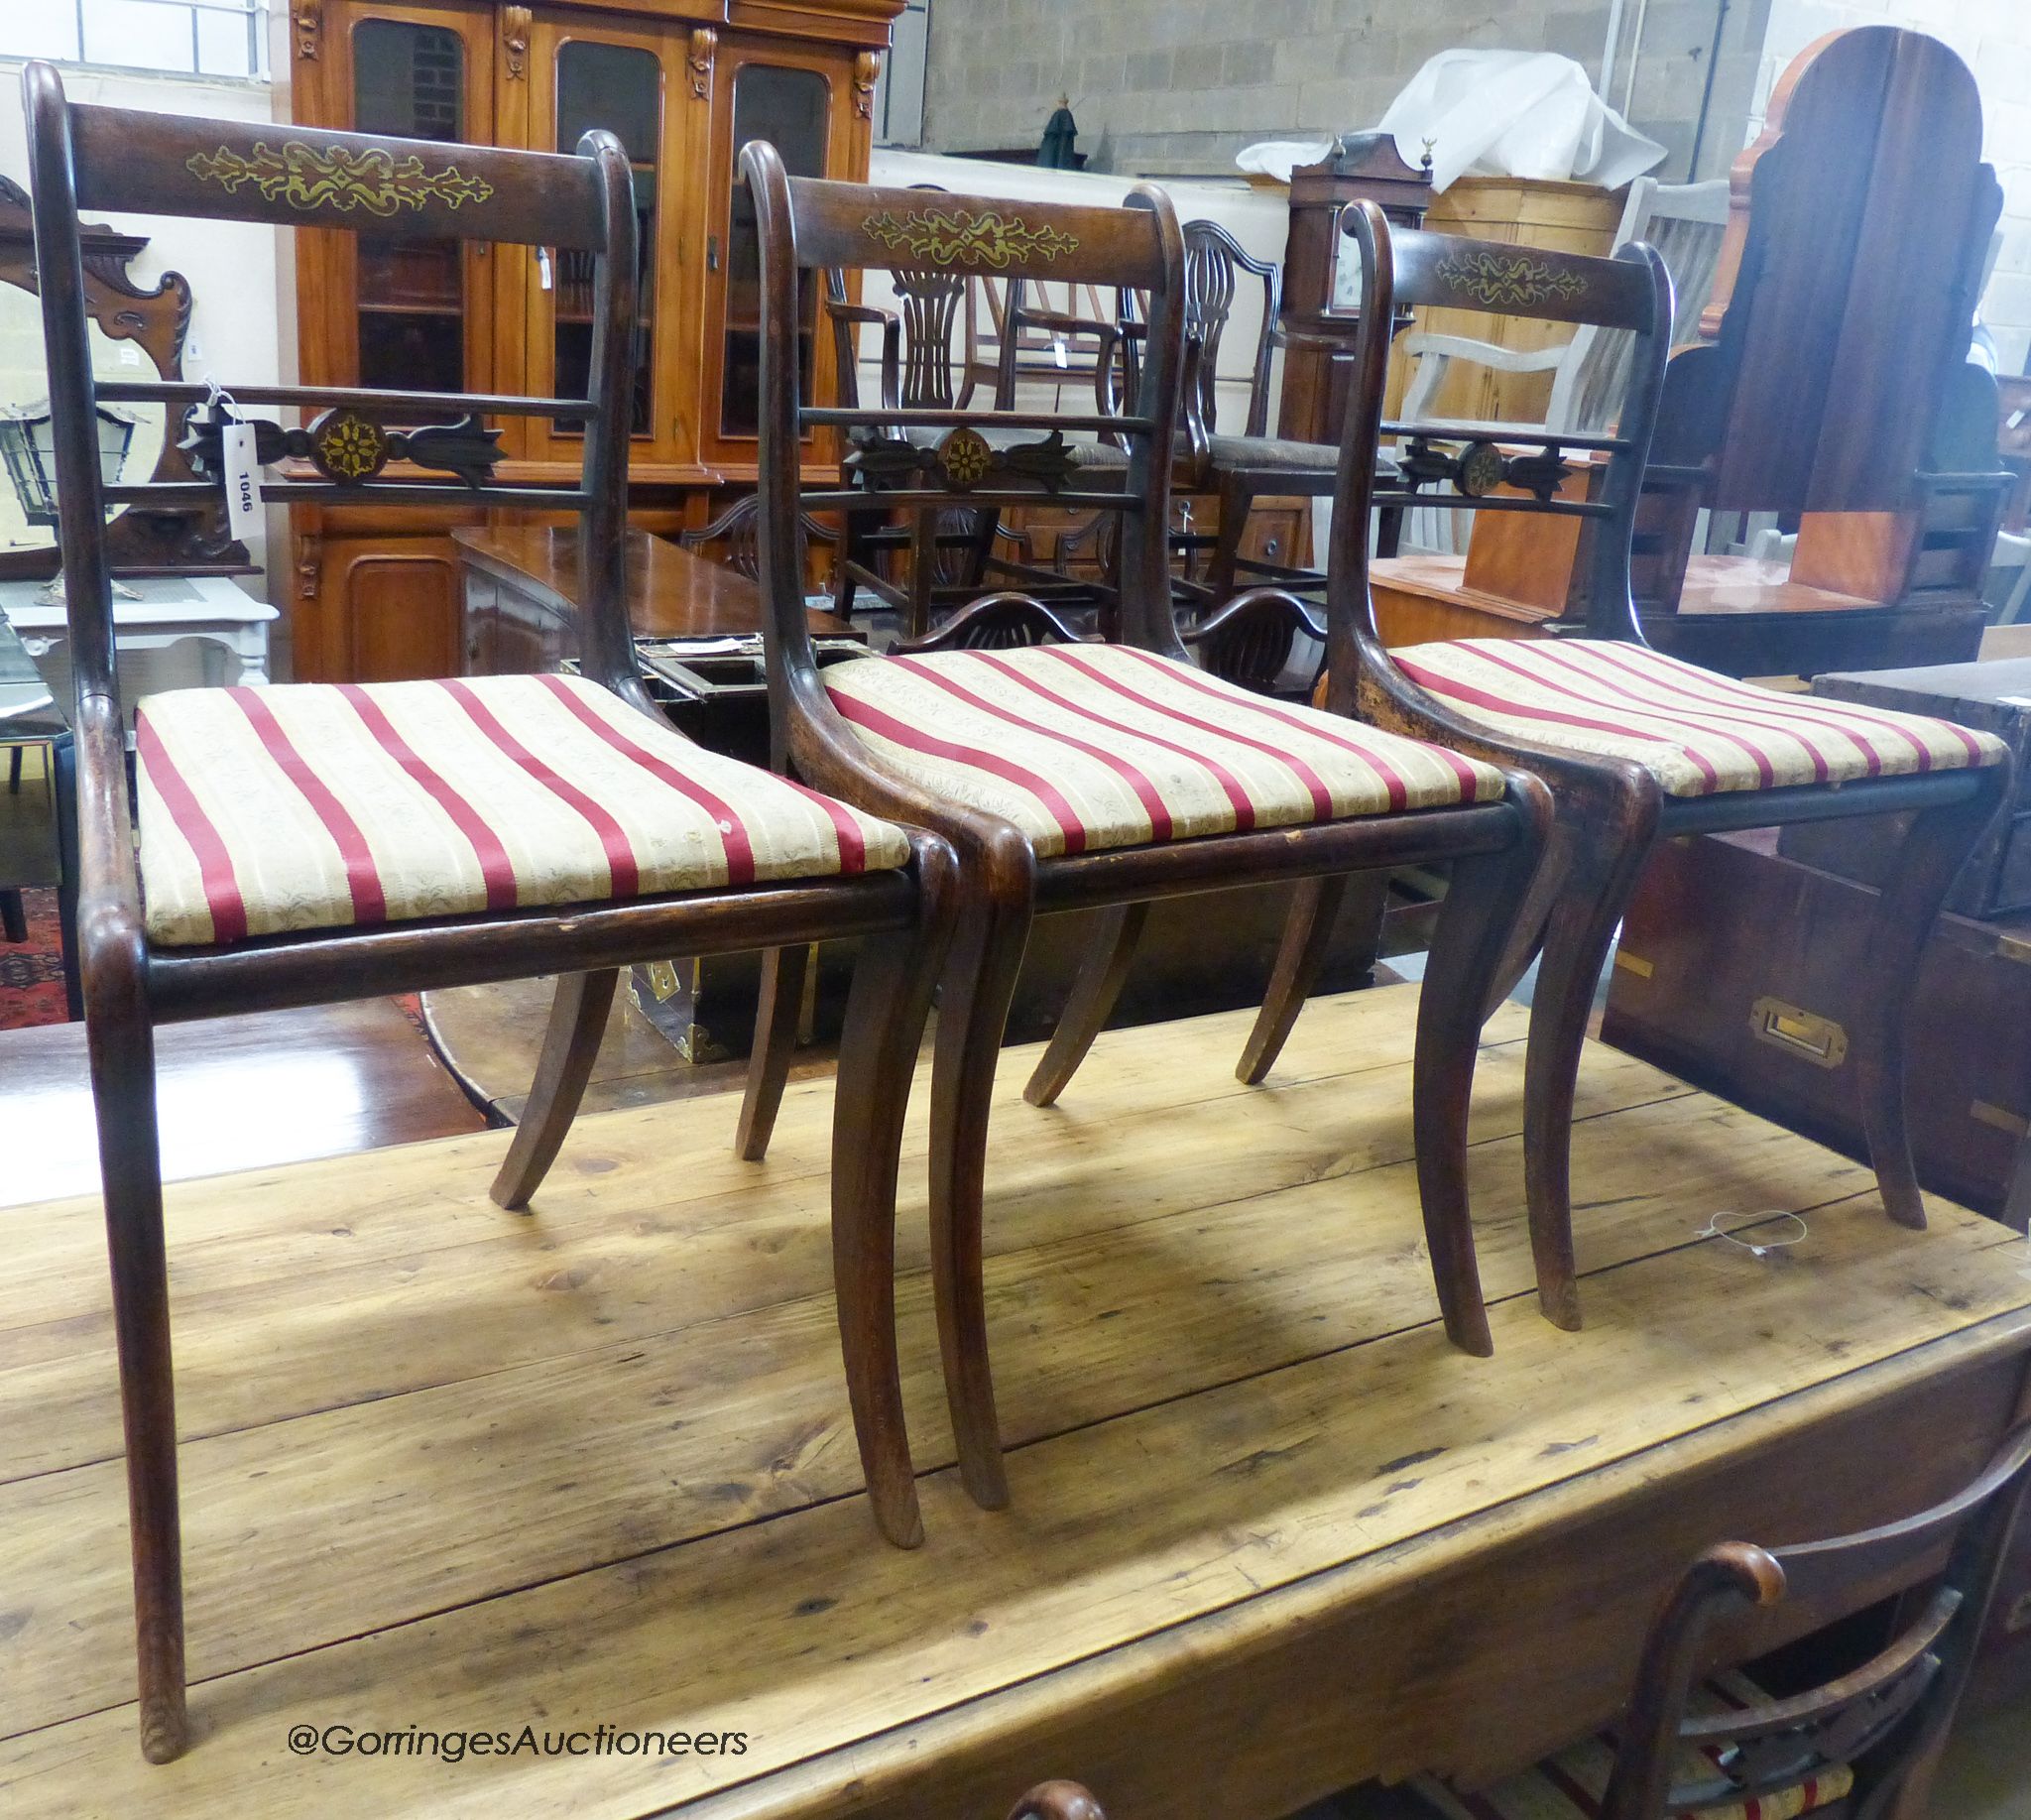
[{"left": 528, "top": 20, "right": 676, "bottom": 461}]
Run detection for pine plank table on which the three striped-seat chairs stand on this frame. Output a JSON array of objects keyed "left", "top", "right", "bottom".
[{"left": 0, "top": 987, "right": 2031, "bottom": 1820}]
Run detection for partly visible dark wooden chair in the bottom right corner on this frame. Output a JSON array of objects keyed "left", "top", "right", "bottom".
[{"left": 1601, "top": 1428, "right": 2031, "bottom": 1820}]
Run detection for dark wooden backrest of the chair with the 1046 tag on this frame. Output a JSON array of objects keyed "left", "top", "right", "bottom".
[{"left": 25, "top": 65, "right": 648, "bottom": 714}]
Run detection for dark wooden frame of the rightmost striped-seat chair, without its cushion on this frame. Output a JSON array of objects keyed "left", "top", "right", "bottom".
[{"left": 1241, "top": 203, "right": 2008, "bottom": 1328}]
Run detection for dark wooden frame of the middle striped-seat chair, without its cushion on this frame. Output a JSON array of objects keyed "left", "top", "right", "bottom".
[{"left": 742, "top": 144, "right": 1550, "bottom": 1508}]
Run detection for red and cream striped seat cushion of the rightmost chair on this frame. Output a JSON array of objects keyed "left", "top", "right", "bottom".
[{"left": 1391, "top": 638, "right": 2004, "bottom": 796}]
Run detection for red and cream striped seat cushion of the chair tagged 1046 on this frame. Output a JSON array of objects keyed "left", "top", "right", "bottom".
[{"left": 134, "top": 676, "right": 910, "bottom": 946}]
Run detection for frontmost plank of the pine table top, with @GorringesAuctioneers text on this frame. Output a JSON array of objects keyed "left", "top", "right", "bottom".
[{"left": 0, "top": 1169, "right": 2031, "bottom": 1816}]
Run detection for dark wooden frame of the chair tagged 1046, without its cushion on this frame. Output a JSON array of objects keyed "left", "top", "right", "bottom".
[{"left": 25, "top": 62, "right": 950, "bottom": 1763}]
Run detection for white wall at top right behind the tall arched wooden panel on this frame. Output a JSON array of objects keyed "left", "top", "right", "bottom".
[{"left": 1744, "top": 0, "right": 2031, "bottom": 374}]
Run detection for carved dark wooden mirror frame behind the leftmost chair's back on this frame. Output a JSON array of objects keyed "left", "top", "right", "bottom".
[{"left": 0, "top": 175, "right": 256, "bottom": 581}]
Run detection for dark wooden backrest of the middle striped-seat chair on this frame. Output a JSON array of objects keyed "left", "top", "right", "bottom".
[{"left": 742, "top": 144, "right": 1184, "bottom": 718}]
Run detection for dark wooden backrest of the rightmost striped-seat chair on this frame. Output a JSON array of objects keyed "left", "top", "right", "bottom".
[{"left": 1326, "top": 201, "right": 1672, "bottom": 713}]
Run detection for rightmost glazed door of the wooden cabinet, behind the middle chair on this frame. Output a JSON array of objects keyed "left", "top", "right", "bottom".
[{"left": 703, "top": 51, "right": 851, "bottom": 463}]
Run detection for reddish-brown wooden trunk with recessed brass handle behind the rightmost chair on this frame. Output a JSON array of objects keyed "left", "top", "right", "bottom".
[{"left": 1603, "top": 833, "right": 2031, "bottom": 1227}]
